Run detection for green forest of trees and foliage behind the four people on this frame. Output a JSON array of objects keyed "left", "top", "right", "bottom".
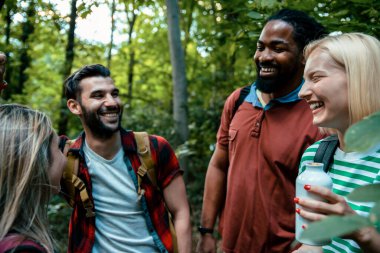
[{"left": 0, "top": 0, "right": 380, "bottom": 252}]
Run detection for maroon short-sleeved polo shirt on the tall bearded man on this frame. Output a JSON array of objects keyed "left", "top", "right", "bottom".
[{"left": 217, "top": 89, "right": 323, "bottom": 253}]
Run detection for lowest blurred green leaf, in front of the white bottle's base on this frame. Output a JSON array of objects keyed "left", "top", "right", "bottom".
[{"left": 301, "top": 215, "right": 372, "bottom": 241}]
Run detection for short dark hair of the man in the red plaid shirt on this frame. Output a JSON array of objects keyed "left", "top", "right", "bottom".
[{"left": 64, "top": 64, "right": 111, "bottom": 100}]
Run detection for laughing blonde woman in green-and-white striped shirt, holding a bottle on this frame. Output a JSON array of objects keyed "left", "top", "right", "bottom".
[{"left": 294, "top": 33, "right": 380, "bottom": 253}]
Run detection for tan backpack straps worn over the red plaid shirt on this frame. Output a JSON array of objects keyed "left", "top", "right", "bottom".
[{"left": 62, "top": 132, "right": 178, "bottom": 253}]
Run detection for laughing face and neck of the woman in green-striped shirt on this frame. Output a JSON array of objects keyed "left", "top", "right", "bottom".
[{"left": 299, "top": 48, "right": 349, "bottom": 133}]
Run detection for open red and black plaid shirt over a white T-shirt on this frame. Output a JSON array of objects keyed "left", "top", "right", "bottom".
[{"left": 61, "top": 130, "right": 182, "bottom": 253}]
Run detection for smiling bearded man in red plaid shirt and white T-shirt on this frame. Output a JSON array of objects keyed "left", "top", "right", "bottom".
[{"left": 62, "top": 64, "right": 191, "bottom": 253}]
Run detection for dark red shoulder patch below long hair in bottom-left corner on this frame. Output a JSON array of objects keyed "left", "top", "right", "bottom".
[{"left": 0, "top": 234, "right": 46, "bottom": 253}]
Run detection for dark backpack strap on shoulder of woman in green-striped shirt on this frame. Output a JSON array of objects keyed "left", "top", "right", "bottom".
[{"left": 314, "top": 135, "right": 339, "bottom": 172}]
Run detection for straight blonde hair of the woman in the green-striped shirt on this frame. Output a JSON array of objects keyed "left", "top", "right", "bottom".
[{"left": 304, "top": 33, "right": 380, "bottom": 125}]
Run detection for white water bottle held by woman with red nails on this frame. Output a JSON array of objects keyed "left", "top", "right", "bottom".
[{"left": 296, "top": 162, "right": 332, "bottom": 246}]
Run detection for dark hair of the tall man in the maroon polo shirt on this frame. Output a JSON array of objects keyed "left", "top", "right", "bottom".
[{"left": 267, "top": 9, "right": 327, "bottom": 51}]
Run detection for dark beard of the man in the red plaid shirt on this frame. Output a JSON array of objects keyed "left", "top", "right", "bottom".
[{"left": 82, "top": 107, "right": 123, "bottom": 139}]
